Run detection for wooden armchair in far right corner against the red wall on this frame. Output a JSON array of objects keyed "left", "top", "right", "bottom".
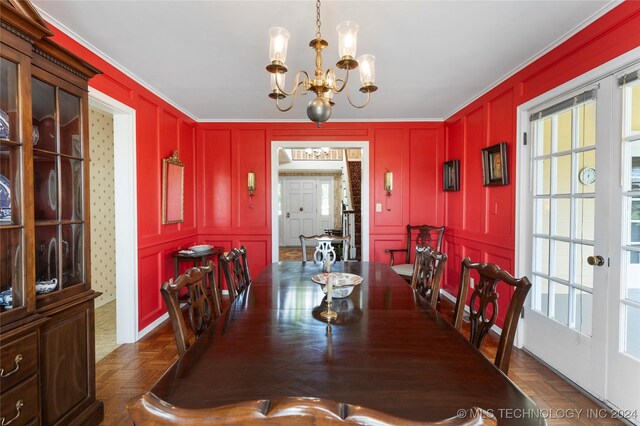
[{"left": 384, "top": 225, "right": 444, "bottom": 282}]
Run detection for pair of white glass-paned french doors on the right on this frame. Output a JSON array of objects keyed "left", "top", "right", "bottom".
[{"left": 520, "top": 60, "right": 640, "bottom": 421}]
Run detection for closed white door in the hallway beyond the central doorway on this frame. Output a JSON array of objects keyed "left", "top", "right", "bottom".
[{"left": 284, "top": 178, "right": 318, "bottom": 246}]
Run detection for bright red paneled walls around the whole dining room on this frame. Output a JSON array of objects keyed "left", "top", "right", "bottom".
[{"left": 48, "top": 1, "right": 640, "bottom": 329}]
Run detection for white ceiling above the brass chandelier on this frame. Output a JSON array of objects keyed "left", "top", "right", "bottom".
[{"left": 33, "top": 0, "right": 619, "bottom": 121}]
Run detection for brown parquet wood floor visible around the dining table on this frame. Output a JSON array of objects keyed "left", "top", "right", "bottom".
[{"left": 96, "top": 298, "right": 622, "bottom": 426}]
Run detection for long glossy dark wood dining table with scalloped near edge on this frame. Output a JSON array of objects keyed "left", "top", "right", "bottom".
[{"left": 129, "top": 262, "right": 546, "bottom": 424}]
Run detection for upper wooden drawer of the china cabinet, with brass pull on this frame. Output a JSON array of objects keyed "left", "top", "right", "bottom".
[{"left": 0, "top": 333, "right": 38, "bottom": 393}]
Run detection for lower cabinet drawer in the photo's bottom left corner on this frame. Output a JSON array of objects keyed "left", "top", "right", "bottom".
[{"left": 0, "top": 376, "right": 40, "bottom": 426}]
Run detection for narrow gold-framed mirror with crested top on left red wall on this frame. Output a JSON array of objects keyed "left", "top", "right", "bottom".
[{"left": 162, "top": 151, "right": 184, "bottom": 225}]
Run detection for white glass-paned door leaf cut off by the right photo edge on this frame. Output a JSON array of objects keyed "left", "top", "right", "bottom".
[{"left": 606, "top": 64, "right": 640, "bottom": 418}]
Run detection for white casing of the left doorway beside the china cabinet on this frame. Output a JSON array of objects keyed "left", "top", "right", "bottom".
[{"left": 89, "top": 87, "right": 138, "bottom": 344}]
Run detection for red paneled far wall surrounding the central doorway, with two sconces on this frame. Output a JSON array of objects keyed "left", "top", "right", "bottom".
[{"left": 196, "top": 122, "right": 444, "bottom": 282}]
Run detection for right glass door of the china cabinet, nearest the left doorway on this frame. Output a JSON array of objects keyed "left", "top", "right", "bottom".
[{"left": 32, "top": 78, "right": 84, "bottom": 295}]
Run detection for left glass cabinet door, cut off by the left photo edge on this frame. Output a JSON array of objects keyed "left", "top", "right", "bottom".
[{"left": 0, "top": 57, "right": 24, "bottom": 313}]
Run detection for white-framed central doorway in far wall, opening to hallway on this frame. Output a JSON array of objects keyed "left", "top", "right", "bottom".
[{"left": 271, "top": 141, "right": 369, "bottom": 262}]
